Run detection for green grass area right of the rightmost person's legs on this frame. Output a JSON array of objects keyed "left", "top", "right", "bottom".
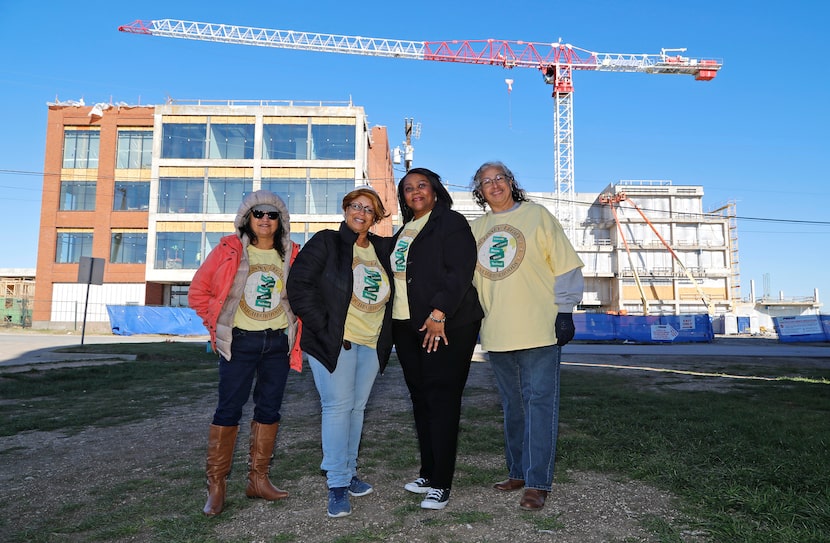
[{"left": 558, "top": 375, "right": 830, "bottom": 543}]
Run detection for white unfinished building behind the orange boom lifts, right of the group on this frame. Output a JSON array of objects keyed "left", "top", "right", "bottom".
[{"left": 453, "top": 181, "right": 740, "bottom": 315}]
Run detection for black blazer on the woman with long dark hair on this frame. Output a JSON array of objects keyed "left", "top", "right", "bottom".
[{"left": 394, "top": 201, "right": 484, "bottom": 332}]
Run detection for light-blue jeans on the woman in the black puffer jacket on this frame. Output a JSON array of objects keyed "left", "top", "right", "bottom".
[{"left": 308, "top": 343, "right": 380, "bottom": 488}]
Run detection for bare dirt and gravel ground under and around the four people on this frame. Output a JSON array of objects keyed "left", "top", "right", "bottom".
[{"left": 0, "top": 342, "right": 827, "bottom": 543}]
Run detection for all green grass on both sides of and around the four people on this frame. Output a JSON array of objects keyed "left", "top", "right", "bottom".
[{"left": 0, "top": 343, "right": 830, "bottom": 543}]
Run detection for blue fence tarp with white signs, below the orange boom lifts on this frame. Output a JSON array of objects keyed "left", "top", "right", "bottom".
[{"left": 574, "top": 313, "right": 715, "bottom": 343}]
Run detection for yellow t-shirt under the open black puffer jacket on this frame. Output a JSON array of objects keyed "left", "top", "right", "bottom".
[{"left": 344, "top": 243, "right": 392, "bottom": 349}]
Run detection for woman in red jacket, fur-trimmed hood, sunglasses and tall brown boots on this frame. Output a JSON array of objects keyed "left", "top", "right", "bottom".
[{"left": 188, "top": 190, "right": 302, "bottom": 516}]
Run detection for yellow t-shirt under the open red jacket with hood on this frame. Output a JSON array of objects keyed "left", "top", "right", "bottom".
[{"left": 233, "top": 245, "right": 288, "bottom": 330}]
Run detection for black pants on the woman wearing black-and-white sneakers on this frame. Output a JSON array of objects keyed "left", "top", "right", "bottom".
[{"left": 392, "top": 321, "right": 481, "bottom": 488}]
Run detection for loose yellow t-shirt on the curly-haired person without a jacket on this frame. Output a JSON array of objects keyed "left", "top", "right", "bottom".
[{"left": 470, "top": 202, "right": 583, "bottom": 352}]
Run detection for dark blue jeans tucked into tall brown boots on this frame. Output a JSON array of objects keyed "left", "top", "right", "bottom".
[{"left": 213, "top": 328, "right": 288, "bottom": 426}]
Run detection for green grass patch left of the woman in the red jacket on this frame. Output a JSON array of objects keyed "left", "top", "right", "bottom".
[{"left": 0, "top": 343, "right": 217, "bottom": 436}]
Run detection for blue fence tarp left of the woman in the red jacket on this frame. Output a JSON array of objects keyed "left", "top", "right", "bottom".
[{"left": 107, "top": 305, "right": 208, "bottom": 336}]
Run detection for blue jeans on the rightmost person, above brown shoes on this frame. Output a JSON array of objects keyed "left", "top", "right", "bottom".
[{"left": 488, "top": 345, "right": 561, "bottom": 491}]
